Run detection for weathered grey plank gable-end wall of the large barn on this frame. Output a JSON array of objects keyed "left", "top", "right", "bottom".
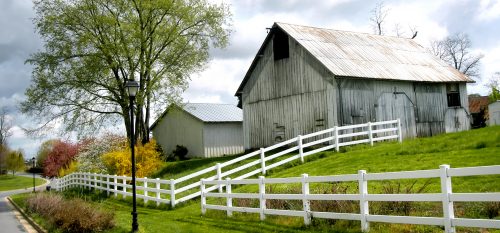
[{"left": 242, "top": 36, "right": 336, "bottom": 149}]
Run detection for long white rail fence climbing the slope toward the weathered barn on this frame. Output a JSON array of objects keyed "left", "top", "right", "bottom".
[{"left": 56, "top": 119, "right": 402, "bottom": 207}]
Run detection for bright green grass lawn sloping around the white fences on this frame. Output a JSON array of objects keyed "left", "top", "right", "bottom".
[{"left": 9, "top": 126, "right": 500, "bottom": 233}]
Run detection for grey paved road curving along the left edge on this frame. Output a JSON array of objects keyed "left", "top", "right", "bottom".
[{"left": 0, "top": 174, "right": 49, "bottom": 233}]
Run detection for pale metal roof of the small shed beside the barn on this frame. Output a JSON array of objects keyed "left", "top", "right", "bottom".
[{"left": 182, "top": 103, "right": 243, "bottom": 122}]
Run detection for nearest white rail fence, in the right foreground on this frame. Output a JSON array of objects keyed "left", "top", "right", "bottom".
[{"left": 200, "top": 165, "right": 500, "bottom": 232}]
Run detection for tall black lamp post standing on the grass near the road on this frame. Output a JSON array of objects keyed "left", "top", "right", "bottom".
[{"left": 125, "top": 80, "right": 139, "bottom": 232}]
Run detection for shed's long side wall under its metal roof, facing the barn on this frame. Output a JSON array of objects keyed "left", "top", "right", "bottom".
[{"left": 203, "top": 122, "right": 245, "bottom": 158}]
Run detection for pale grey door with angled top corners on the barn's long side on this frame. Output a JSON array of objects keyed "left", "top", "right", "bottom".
[{"left": 375, "top": 93, "right": 417, "bottom": 138}]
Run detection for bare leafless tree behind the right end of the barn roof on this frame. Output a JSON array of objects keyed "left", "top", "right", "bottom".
[{"left": 430, "top": 33, "right": 484, "bottom": 78}]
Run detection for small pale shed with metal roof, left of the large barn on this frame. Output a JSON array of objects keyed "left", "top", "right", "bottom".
[{"left": 151, "top": 103, "right": 244, "bottom": 158}]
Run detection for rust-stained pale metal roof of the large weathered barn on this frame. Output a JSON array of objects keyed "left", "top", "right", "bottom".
[{"left": 237, "top": 23, "right": 474, "bottom": 94}]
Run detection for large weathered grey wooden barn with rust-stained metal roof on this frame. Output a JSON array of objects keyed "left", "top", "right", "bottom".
[{"left": 235, "top": 23, "right": 473, "bottom": 149}]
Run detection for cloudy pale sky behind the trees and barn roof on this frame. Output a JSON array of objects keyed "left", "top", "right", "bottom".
[{"left": 0, "top": 0, "right": 500, "bottom": 158}]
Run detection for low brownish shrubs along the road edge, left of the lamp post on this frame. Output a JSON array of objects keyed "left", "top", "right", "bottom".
[{"left": 26, "top": 193, "right": 114, "bottom": 232}]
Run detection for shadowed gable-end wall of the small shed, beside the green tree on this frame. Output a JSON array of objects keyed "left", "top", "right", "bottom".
[{"left": 153, "top": 108, "right": 205, "bottom": 157}]
